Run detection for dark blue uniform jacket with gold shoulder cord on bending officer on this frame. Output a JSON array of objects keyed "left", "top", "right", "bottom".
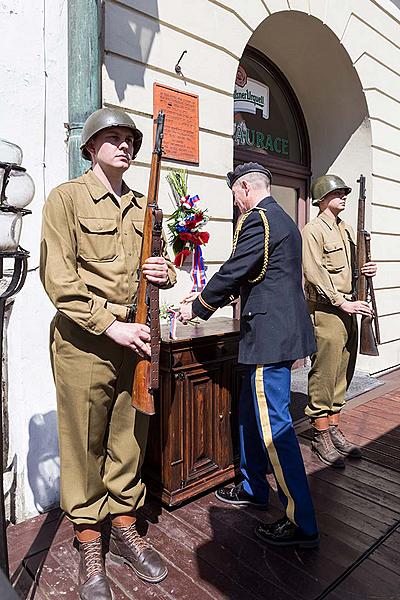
[{"left": 193, "top": 197, "right": 316, "bottom": 365}]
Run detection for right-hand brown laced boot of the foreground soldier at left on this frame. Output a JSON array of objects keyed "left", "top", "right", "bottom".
[{"left": 110, "top": 523, "right": 168, "bottom": 583}]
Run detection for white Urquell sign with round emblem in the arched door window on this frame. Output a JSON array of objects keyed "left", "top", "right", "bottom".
[{"left": 233, "top": 65, "right": 269, "bottom": 119}]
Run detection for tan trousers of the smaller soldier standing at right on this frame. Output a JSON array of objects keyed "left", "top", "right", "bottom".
[{"left": 305, "top": 302, "right": 358, "bottom": 418}]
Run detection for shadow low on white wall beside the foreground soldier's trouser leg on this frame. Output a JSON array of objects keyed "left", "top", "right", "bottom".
[{"left": 27, "top": 410, "right": 60, "bottom": 513}]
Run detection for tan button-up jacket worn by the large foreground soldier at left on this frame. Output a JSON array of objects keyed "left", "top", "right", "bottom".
[{"left": 40, "top": 170, "right": 175, "bottom": 335}]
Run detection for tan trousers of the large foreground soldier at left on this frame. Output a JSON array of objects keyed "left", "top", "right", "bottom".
[{"left": 51, "top": 313, "right": 149, "bottom": 526}]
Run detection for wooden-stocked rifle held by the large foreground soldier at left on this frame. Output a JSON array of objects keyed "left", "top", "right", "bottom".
[{"left": 132, "top": 110, "right": 165, "bottom": 415}]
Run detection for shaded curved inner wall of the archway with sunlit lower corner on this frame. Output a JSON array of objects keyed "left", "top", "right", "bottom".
[{"left": 249, "top": 11, "right": 371, "bottom": 181}]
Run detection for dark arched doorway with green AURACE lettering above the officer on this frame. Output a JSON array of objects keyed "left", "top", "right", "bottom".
[{"left": 234, "top": 46, "right": 311, "bottom": 228}]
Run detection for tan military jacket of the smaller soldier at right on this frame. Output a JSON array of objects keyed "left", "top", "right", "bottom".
[{"left": 302, "top": 214, "right": 355, "bottom": 306}]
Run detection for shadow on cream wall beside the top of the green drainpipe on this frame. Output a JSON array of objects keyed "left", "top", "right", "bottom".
[{"left": 104, "top": 0, "right": 160, "bottom": 102}]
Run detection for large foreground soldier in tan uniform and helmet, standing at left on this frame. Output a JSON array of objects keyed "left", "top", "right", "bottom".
[{"left": 41, "top": 109, "right": 175, "bottom": 600}]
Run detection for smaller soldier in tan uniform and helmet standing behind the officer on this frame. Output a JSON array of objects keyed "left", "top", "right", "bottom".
[{"left": 302, "top": 175, "right": 376, "bottom": 468}]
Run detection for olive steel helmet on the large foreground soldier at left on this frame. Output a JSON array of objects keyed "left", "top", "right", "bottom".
[{"left": 80, "top": 108, "right": 143, "bottom": 160}]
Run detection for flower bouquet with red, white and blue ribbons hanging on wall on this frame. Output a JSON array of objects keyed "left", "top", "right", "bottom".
[{"left": 167, "top": 169, "right": 210, "bottom": 292}]
